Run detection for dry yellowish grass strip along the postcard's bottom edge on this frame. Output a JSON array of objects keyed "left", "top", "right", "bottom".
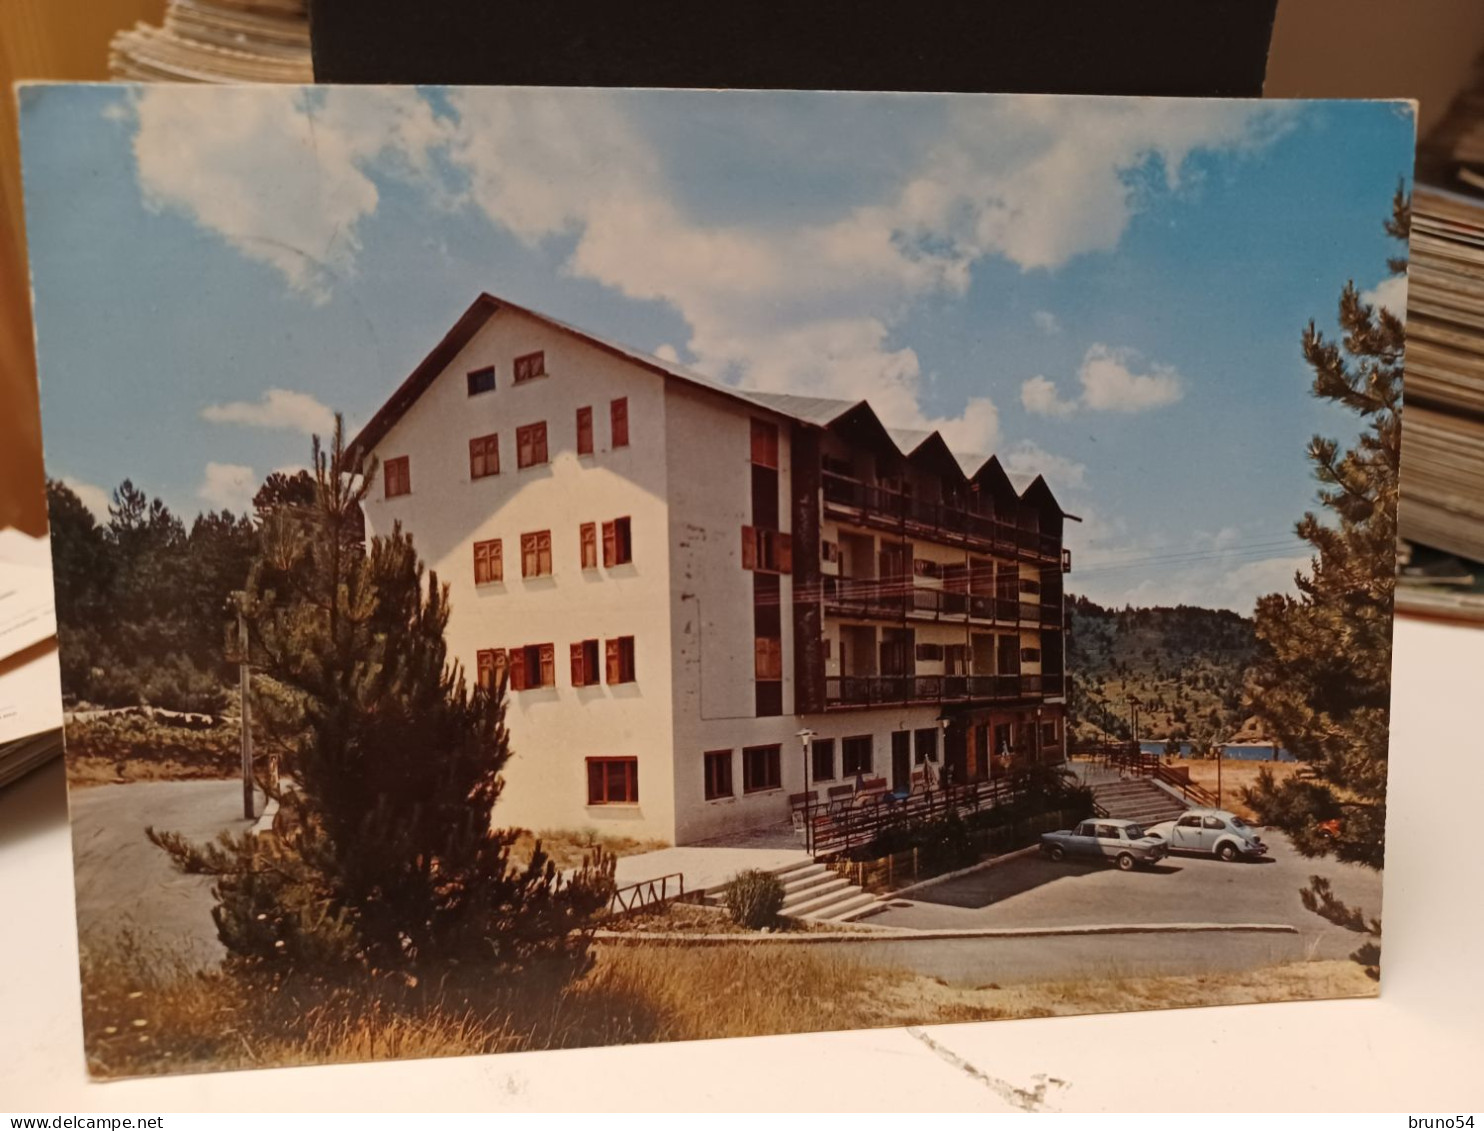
[{"left": 83, "top": 937, "right": 1376, "bottom": 1076}]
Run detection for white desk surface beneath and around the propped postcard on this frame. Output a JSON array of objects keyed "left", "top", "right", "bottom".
[{"left": 0, "top": 611, "right": 1484, "bottom": 1113}]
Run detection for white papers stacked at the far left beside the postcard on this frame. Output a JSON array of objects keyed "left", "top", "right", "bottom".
[{"left": 0, "top": 530, "right": 62, "bottom": 785}]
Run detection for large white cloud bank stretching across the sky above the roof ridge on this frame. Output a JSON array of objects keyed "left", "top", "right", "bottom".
[{"left": 124, "top": 88, "right": 1291, "bottom": 450}]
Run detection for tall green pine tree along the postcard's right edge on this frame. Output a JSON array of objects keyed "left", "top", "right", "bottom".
[{"left": 1248, "top": 189, "right": 1410, "bottom": 872}]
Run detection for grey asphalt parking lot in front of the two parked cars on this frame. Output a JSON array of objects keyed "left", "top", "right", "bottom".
[{"left": 870, "top": 831, "right": 1382, "bottom": 959}]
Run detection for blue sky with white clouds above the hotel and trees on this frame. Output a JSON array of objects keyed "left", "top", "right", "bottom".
[{"left": 21, "top": 86, "right": 1413, "bottom": 612}]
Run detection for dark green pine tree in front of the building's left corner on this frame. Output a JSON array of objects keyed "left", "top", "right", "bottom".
[{"left": 150, "top": 422, "right": 613, "bottom": 977}]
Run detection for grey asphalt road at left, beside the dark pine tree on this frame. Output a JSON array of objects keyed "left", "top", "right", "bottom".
[{"left": 70, "top": 781, "right": 263, "bottom": 966}]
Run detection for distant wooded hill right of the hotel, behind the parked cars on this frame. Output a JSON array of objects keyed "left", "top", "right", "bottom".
[{"left": 1067, "top": 595, "right": 1257, "bottom": 739}]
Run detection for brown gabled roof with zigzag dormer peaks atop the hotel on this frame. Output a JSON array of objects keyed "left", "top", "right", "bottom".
[{"left": 350, "top": 292, "right": 1080, "bottom": 521}]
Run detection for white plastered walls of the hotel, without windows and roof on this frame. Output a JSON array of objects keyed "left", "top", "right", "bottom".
[{"left": 358, "top": 297, "right": 1068, "bottom": 843}]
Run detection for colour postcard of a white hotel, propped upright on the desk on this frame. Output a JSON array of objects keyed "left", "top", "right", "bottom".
[{"left": 19, "top": 85, "right": 1414, "bottom": 1078}]
